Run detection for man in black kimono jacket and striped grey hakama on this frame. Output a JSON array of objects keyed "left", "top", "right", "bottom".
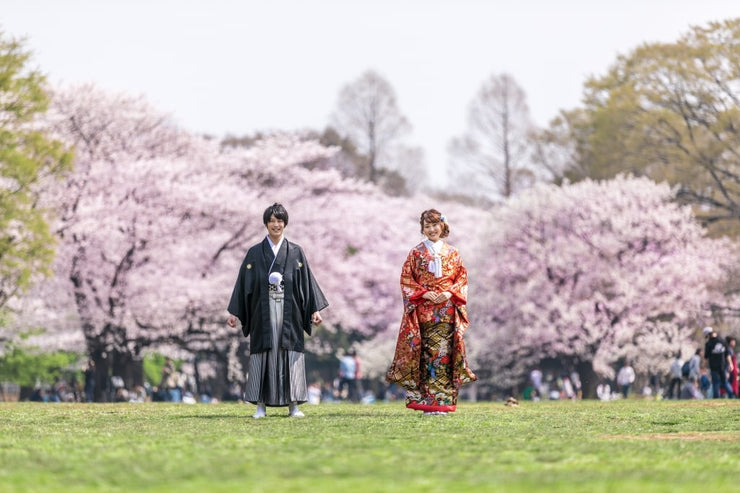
[{"left": 226, "top": 203, "right": 328, "bottom": 418}]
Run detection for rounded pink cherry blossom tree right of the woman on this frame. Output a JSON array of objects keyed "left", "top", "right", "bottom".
[{"left": 470, "top": 176, "right": 737, "bottom": 395}]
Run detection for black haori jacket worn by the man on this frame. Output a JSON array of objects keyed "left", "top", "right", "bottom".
[{"left": 228, "top": 237, "right": 329, "bottom": 354}]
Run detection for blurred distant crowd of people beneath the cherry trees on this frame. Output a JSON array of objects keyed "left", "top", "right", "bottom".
[{"left": 20, "top": 320, "right": 740, "bottom": 404}]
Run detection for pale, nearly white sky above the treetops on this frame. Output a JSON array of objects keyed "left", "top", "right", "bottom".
[{"left": 0, "top": 0, "right": 740, "bottom": 181}]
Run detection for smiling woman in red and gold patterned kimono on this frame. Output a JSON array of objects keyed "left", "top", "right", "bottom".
[{"left": 386, "top": 209, "right": 477, "bottom": 415}]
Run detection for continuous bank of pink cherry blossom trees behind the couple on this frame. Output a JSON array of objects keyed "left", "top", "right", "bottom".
[{"left": 15, "top": 82, "right": 736, "bottom": 404}]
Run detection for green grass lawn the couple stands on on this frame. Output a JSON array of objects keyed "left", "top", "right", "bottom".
[{"left": 0, "top": 400, "right": 740, "bottom": 493}]
